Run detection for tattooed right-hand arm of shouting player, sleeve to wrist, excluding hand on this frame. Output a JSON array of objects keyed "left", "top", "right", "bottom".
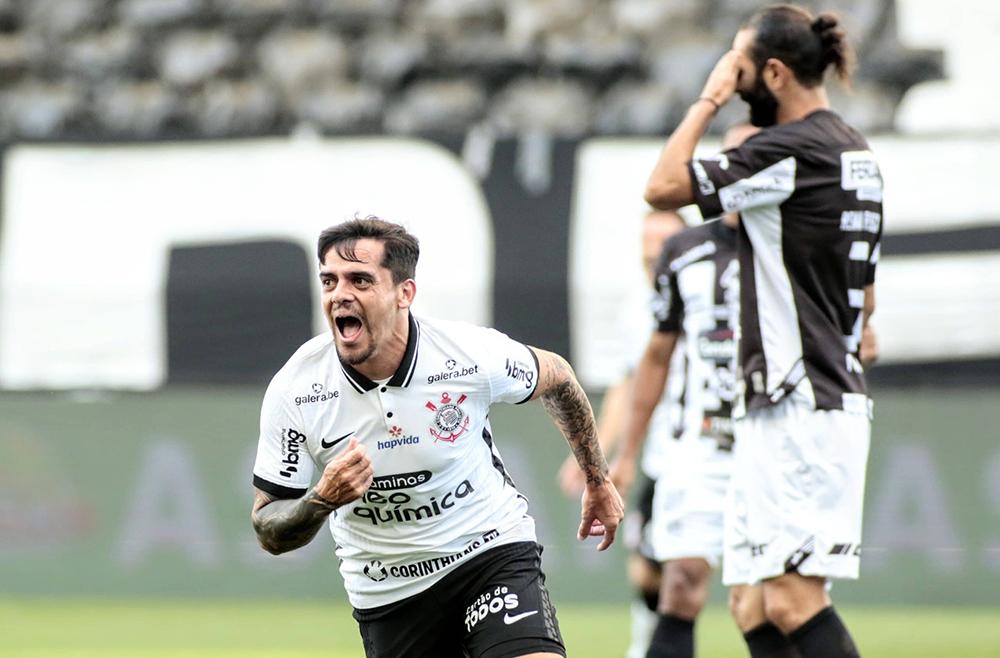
[{"left": 539, "top": 353, "right": 608, "bottom": 485}]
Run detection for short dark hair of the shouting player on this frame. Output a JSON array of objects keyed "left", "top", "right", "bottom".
[{"left": 316, "top": 215, "right": 420, "bottom": 284}]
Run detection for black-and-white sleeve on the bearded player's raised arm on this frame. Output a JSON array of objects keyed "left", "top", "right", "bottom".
[{"left": 688, "top": 133, "right": 796, "bottom": 217}]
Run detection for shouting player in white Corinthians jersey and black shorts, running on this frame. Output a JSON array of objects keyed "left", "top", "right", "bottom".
[{"left": 252, "top": 217, "right": 623, "bottom": 658}]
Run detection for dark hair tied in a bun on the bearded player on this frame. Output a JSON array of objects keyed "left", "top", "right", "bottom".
[{"left": 746, "top": 5, "right": 854, "bottom": 87}]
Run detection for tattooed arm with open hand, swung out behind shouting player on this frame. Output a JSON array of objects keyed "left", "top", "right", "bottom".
[{"left": 531, "top": 347, "right": 625, "bottom": 551}]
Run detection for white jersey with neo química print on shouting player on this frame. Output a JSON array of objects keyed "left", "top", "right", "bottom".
[{"left": 253, "top": 315, "right": 538, "bottom": 609}]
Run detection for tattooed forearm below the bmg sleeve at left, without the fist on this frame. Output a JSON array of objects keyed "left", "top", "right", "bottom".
[{"left": 250, "top": 489, "right": 336, "bottom": 555}]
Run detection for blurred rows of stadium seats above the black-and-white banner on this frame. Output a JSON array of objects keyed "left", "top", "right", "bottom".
[{"left": 0, "top": 0, "right": 943, "bottom": 140}]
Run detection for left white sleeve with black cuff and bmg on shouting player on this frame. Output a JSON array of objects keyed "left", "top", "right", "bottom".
[{"left": 253, "top": 379, "right": 313, "bottom": 498}]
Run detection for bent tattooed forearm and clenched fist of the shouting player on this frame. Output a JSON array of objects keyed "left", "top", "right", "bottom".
[{"left": 250, "top": 438, "right": 372, "bottom": 555}]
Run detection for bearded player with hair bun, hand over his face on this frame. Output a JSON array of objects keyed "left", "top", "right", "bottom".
[{"left": 646, "top": 5, "right": 882, "bottom": 658}]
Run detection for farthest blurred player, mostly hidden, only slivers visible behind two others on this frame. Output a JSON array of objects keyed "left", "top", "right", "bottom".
[{"left": 559, "top": 210, "right": 686, "bottom": 658}]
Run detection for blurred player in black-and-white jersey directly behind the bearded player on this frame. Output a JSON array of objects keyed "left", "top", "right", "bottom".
[{"left": 612, "top": 124, "right": 757, "bottom": 658}]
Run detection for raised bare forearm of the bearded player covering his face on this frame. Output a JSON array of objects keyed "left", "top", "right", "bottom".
[{"left": 645, "top": 100, "right": 716, "bottom": 210}]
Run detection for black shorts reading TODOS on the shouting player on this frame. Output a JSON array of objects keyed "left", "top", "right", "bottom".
[{"left": 354, "top": 542, "right": 566, "bottom": 658}]
